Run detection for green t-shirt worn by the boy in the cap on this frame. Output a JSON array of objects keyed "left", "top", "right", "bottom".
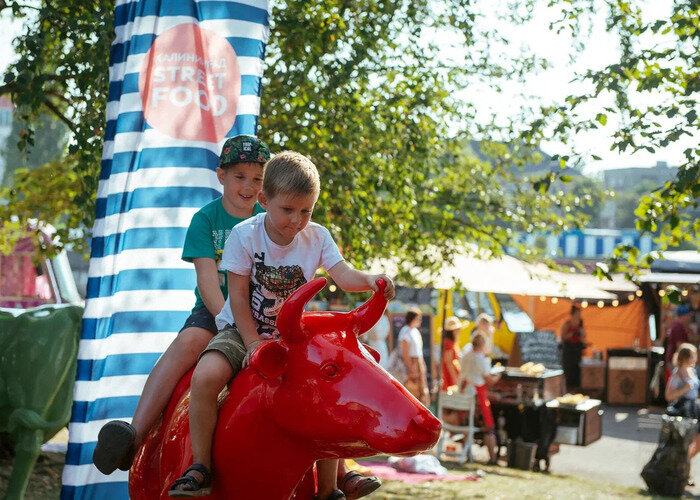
[{"left": 182, "top": 198, "right": 265, "bottom": 311}]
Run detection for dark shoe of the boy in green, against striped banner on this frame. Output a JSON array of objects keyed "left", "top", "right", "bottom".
[{"left": 92, "top": 420, "right": 136, "bottom": 474}]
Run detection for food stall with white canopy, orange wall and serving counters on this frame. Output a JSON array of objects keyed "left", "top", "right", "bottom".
[{"left": 372, "top": 249, "right": 649, "bottom": 468}]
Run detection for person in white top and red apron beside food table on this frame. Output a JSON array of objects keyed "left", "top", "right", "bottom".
[{"left": 459, "top": 332, "right": 501, "bottom": 465}]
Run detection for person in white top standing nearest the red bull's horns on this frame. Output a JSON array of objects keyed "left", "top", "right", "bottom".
[{"left": 398, "top": 308, "right": 430, "bottom": 406}]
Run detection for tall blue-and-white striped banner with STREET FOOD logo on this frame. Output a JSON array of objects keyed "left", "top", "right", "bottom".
[{"left": 61, "top": 0, "right": 269, "bottom": 500}]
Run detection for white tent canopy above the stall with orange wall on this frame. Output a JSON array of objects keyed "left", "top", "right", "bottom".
[{"left": 372, "top": 245, "right": 637, "bottom": 300}]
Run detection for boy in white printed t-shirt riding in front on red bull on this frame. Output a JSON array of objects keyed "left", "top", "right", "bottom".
[{"left": 169, "top": 151, "right": 394, "bottom": 500}]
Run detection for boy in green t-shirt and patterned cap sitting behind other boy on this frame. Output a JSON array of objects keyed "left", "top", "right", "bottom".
[{"left": 92, "top": 135, "right": 270, "bottom": 474}]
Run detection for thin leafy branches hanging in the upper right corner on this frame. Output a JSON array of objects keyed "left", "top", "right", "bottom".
[{"left": 524, "top": 0, "right": 700, "bottom": 276}]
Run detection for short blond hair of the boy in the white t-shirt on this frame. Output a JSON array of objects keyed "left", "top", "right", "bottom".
[{"left": 263, "top": 151, "right": 321, "bottom": 198}]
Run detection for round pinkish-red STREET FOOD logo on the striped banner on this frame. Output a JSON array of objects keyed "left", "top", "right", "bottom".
[{"left": 139, "top": 23, "right": 241, "bottom": 142}]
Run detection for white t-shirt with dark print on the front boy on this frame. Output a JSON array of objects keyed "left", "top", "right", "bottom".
[{"left": 216, "top": 213, "right": 344, "bottom": 334}]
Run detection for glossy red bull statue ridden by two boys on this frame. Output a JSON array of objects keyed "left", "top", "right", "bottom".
[{"left": 129, "top": 278, "right": 440, "bottom": 500}]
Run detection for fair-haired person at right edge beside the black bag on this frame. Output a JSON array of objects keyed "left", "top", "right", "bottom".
[{"left": 666, "top": 343, "right": 700, "bottom": 460}]
